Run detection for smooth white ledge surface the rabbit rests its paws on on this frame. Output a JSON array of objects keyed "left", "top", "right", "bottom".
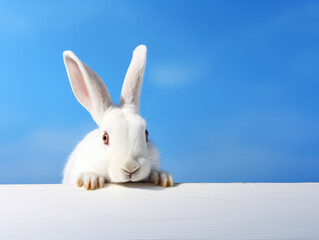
[{"left": 0, "top": 183, "right": 319, "bottom": 240}]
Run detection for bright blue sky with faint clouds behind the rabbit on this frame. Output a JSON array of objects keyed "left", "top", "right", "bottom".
[{"left": 0, "top": 1, "right": 319, "bottom": 184}]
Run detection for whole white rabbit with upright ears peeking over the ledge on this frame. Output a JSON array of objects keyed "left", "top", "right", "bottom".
[{"left": 62, "top": 45, "right": 174, "bottom": 190}]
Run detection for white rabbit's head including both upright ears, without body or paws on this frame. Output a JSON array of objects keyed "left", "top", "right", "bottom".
[{"left": 63, "top": 45, "right": 159, "bottom": 182}]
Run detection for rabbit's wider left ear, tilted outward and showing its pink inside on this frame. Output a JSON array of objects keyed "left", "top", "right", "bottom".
[{"left": 63, "top": 51, "right": 113, "bottom": 125}]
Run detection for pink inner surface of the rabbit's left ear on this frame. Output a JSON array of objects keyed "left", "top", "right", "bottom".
[{"left": 66, "top": 58, "right": 91, "bottom": 109}]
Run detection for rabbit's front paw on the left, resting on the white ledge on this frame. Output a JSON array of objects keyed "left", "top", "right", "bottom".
[{"left": 76, "top": 172, "right": 105, "bottom": 190}]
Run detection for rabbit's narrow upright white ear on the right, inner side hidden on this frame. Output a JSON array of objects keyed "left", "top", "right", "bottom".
[{"left": 120, "top": 45, "right": 147, "bottom": 111}]
